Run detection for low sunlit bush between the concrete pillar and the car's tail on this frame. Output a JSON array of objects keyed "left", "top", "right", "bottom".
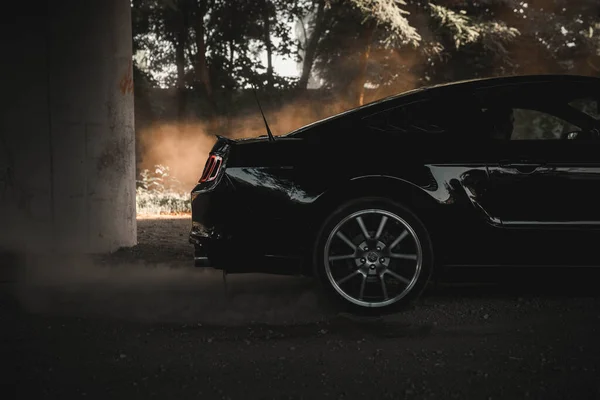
[{"left": 136, "top": 164, "right": 191, "bottom": 215}]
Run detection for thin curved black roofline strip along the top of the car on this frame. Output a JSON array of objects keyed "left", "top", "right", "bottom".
[{"left": 283, "top": 74, "right": 600, "bottom": 136}]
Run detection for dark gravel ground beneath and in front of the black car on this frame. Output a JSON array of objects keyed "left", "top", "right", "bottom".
[{"left": 0, "top": 216, "right": 600, "bottom": 399}]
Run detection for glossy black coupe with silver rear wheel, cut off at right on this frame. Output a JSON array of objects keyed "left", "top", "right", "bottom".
[{"left": 190, "top": 75, "right": 600, "bottom": 313}]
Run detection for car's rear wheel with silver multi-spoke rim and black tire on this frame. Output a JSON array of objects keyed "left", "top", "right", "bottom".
[{"left": 313, "top": 198, "right": 433, "bottom": 315}]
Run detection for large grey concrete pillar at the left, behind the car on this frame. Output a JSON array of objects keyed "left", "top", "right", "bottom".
[{"left": 0, "top": 0, "right": 136, "bottom": 253}]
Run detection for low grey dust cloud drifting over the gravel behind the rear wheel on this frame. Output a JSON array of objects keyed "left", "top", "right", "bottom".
[{"left": 15, "top": 254, "right": 328, "bottom": 326}]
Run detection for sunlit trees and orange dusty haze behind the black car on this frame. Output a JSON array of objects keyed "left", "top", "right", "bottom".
[{"left": 131, "top": 0, "right": 600, "bottom": 213}]
